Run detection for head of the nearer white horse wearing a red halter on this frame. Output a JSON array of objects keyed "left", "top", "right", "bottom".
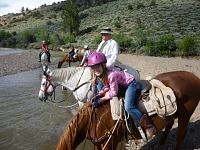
[{"left": 38, "top": 75, "right": 56, "bottom": 101}]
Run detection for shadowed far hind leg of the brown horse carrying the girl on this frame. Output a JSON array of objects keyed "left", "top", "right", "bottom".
[{"left": 154, "top": 119, "right": 174, "bottom": 149}]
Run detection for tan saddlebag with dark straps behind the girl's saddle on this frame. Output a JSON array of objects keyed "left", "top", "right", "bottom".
[{"left": 149, "top": 79, "right": 177, "bottom": 117}]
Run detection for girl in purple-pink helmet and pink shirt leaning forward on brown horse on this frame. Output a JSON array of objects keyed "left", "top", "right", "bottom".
[{"left": 88, "top": 52, "right": 155, "bottom": 139}]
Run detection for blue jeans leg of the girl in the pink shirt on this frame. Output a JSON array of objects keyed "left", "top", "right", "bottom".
[{"left": 125, "top": 79, "right": 143, "bottom": 122}]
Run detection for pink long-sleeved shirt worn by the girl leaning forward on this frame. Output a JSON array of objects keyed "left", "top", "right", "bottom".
[{"left": 102, "top": 67, "right": 134, "bottom": 100}]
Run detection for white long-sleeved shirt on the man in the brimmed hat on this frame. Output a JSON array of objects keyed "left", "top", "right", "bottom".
[{"left": 97, "top": 39, "right": 118, "bottom": 67}]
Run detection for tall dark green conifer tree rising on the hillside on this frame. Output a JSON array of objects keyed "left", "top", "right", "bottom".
[{"left": 61, "top": 0, "right": 80, "bottom": 36}]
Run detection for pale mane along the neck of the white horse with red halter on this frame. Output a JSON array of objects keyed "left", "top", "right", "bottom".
[{"left": 50, "top": 67, "right": 83, "bottom": 81}]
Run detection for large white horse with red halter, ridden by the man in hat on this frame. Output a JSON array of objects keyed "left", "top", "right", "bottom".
[{"left": 38, "top": 65, "right": 140, "bottom": 107}]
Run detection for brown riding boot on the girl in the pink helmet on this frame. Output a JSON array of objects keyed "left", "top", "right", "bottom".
[{"left": 140, "top": 114, "right": 156, "bottom": 140}]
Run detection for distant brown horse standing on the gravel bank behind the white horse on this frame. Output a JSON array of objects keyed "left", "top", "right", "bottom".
[{"left": 58, "top": 53, "right": 83, "bottom": 68}]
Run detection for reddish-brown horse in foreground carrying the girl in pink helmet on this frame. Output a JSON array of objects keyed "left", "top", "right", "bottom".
[{"left": 56, "top": 71, "right": 200, "bottom": 150}]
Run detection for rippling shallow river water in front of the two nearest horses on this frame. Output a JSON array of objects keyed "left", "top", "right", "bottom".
[{"left": 0, "top": 62, "right": 94, "bottom": 150}]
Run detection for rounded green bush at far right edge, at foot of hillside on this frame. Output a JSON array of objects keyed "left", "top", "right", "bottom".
[{"left": 177, "top": 36, "right": 197, "bottom": 56}]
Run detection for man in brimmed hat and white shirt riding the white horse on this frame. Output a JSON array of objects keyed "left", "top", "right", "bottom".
[{"left": 97, "top": 27, "right": 119, "bottom": 67}]
